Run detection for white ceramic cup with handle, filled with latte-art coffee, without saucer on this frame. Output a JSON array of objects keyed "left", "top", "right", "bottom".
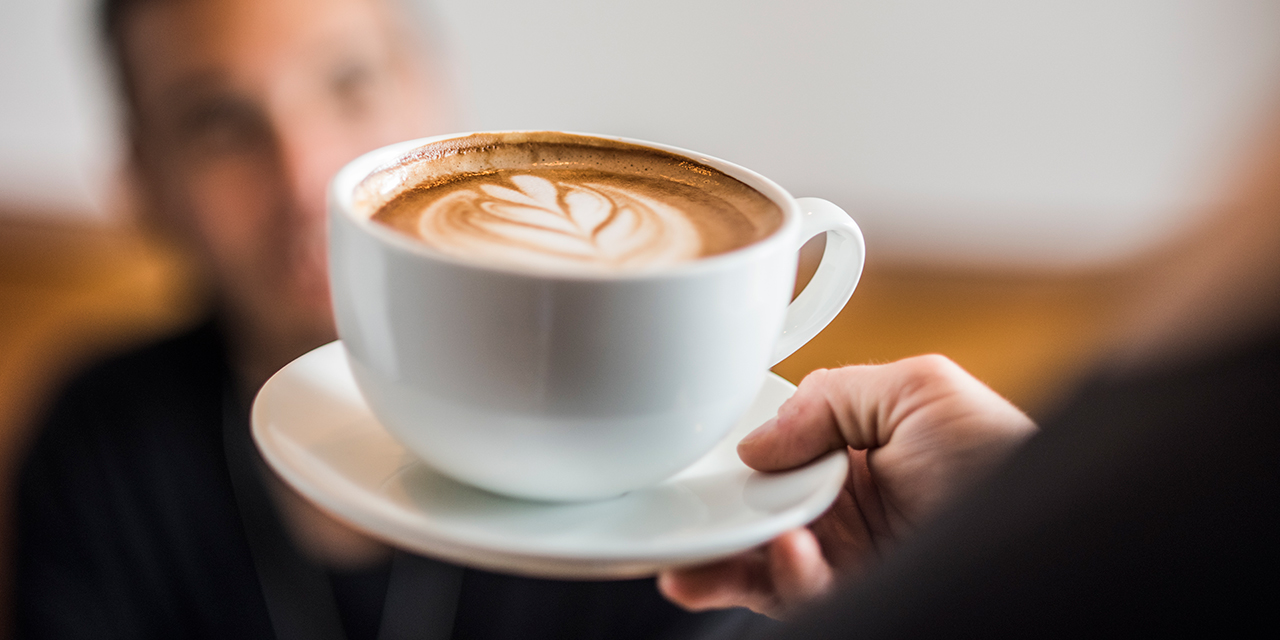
[{"left": 329, "top": 132, "right": 863, "bottom": 500}]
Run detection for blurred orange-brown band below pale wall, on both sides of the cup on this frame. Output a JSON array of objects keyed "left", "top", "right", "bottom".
[{"left": 0, "top": 216, "right": 1116, "bottom": 634}]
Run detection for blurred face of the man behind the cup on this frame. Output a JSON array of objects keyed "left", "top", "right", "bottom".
[{"left": 124, "top": 0, "right": 436, "bottom": 344}]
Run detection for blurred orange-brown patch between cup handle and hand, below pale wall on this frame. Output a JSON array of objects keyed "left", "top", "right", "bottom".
[{"left": 774, "top": 252, "right": 1119, "bottom": 415}]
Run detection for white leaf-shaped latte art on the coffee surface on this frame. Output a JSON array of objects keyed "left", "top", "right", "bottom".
[{"left": 417, "top": 174, "right": 701, "bottom": 270}]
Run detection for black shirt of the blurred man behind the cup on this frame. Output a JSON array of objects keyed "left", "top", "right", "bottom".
[{"left": 15, "top": 324, "right": 741, "bottom": 639}]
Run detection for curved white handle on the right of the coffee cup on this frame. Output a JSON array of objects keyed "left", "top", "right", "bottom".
[{"left": 769, "top": 198, "right": 867, "bottom": 366}]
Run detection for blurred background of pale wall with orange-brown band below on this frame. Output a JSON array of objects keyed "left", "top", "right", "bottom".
[{"left": 0, "top": 0, "right": 1280, "bottom": 632}]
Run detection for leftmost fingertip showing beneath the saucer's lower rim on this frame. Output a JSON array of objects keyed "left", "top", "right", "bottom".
[{"left": 658, "top": 549, "right": 777, "bottom": 614}]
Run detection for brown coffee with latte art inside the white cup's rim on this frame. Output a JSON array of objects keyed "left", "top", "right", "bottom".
[{"left": 356, "top": 132, "right": 783, "bottom": 273}]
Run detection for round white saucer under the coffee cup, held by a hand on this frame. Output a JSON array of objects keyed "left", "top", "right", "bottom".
[{"left": 252, "top": 342, "right": 849, "bottom": 579}]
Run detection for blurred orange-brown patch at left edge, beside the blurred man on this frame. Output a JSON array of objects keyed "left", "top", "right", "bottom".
[{"left": 0, "top": 216, "right": 196, "bottom": 637}]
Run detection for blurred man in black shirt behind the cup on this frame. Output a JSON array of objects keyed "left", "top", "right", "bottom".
[{"left": 15, "top": 0, "right": 747, "bottom": 639}]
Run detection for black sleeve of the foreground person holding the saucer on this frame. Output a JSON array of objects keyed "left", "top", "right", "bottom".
[{"left": 762, "top": 339, "right": 1280, "bottom": 640}]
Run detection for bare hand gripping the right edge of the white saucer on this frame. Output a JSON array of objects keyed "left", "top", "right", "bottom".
[{"left": 658, "top": 356, "right": 1037, "bottom": 617}]
